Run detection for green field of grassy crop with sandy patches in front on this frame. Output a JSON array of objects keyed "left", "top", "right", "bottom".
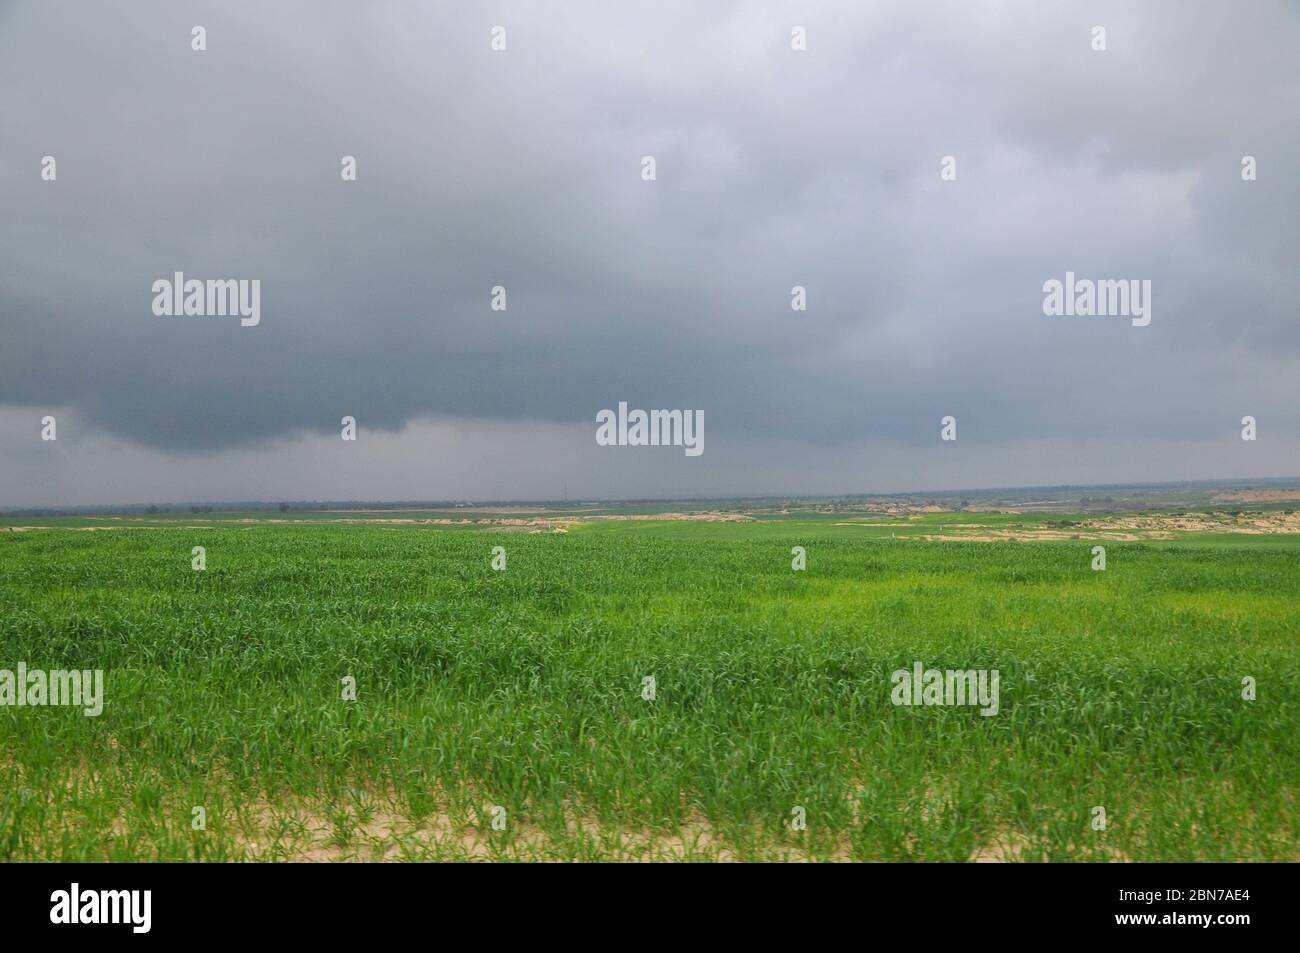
[{"left": 0, "top": 514, "right": 1300, "bottom": 861}]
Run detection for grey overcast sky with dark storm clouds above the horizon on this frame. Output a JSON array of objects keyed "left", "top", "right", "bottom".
[{"left": 0, "top": 0, "right": 1300, "bottom": 507}]
